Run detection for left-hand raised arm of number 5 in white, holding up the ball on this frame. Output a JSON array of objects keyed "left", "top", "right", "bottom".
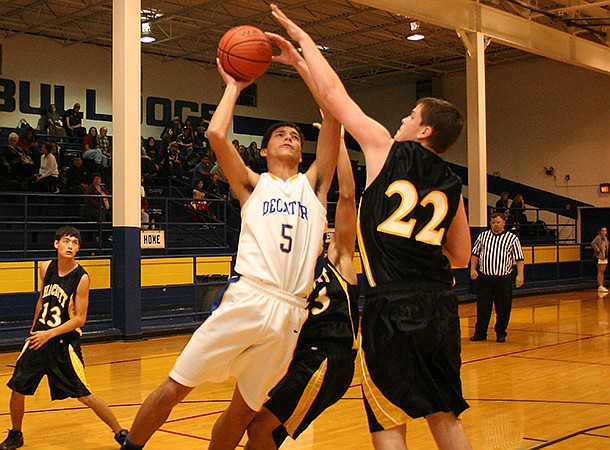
[{"left": 207, "top": 59, "right": 259, "bottom": 205}]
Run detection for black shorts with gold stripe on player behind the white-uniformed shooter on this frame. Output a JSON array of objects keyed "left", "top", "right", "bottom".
[{"left": 264, "top": 343, "right": 356, "bottom": 447}]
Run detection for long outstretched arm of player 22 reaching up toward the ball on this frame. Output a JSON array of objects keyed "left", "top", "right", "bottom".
[{"left": 271, "top": 4, "right": 393, "bottom": 181}]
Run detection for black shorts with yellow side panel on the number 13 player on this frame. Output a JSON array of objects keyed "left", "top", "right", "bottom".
[{"left": 7, "top": 336, "right": 91, "bottom": 400}]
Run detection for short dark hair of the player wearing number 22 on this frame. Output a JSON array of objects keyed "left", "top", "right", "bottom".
[{"left": 417, "top": 97, "right": 464, "bottom": 153}]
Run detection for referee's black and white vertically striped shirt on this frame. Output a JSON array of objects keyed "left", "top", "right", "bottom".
[{"left": 472, "top": 230, "right": 524, "bottom": 276}]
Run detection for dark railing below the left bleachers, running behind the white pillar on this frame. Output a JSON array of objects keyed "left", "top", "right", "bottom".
[{"left": 0, "top": 192, "right": 239, "bottom": 260}]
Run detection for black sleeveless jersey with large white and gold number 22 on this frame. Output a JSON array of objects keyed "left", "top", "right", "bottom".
[{"left": 358, "top": 141, "right": 462, "bottom": 287}]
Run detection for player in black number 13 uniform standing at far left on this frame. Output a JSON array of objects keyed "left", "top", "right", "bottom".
[{"left": 0, "top": 226, "right": 127, "bottom": 450}]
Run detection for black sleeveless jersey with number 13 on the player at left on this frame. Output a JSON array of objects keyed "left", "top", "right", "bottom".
[{"left": 34, "top": 259, "right": 87, "bottom": 336}]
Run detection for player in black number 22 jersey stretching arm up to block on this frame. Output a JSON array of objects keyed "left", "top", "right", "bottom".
[{"left": 271, "top": 5, "right": 470, "bottom": 449}]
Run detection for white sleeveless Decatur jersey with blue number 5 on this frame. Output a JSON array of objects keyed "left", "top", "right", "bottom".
[{"left": 235, "top": 173, "right": 326, "bottom": 297}]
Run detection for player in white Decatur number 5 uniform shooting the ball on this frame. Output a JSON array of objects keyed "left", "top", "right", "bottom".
[{"left": 122, "top": 33, "right": 340, "bottom": 450}]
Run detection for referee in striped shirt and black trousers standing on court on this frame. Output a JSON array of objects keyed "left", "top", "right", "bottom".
[{"left": 470, "top": 213, "right": 524, "bottom": 342}]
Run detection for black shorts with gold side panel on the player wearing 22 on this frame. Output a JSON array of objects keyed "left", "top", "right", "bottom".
[{"left": 360, "top": 282, "right": 468, "bottom": 432}]
